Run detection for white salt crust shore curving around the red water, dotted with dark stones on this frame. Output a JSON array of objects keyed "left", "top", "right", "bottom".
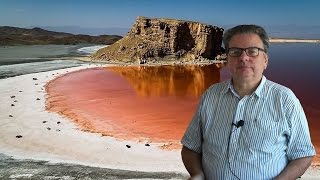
[{"left": 0, "top": 64, "right": 320, "bottom": 179}]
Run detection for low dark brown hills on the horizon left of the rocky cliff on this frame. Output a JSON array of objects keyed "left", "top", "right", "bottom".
[{"left": 0, "top": 26, "right": 122, "bottom": 46}]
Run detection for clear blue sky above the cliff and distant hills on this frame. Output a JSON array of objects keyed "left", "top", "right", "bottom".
[{"left": 0, "top": 0, "right": 320, "bottom": 38}]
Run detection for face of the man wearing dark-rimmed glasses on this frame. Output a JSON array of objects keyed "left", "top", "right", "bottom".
[{"left": 227, "top": 34, "right": 268, "bottom": 81}]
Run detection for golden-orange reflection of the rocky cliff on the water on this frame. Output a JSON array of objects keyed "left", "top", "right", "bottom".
[{"left": 106, "top": 64, "right": 220, "bottom": 97}]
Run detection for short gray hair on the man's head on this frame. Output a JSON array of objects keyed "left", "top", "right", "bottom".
[{"left": 223, "top": 25, "right": 269, "bottom": 52}]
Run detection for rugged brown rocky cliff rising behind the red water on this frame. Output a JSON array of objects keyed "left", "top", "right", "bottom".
[{"left": 92, "top": 17, "right": 223, "bottom": 64}]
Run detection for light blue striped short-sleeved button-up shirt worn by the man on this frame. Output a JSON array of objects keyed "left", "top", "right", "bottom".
[{"left": 181, "top": 76, "right": 315, "bottom": 180}]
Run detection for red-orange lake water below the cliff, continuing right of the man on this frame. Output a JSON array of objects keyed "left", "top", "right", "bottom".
[{"left": 46, "top": 65, "right": 320, "bottom": 162}]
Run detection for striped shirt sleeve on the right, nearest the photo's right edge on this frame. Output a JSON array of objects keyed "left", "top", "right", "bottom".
[{"left": 287, "top": 97, "right": 316, "bottom": 160}]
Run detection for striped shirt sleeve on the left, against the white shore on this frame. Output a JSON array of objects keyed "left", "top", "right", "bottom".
[{"left": 181, "top": 95, "right": 205, "bottom": 154}]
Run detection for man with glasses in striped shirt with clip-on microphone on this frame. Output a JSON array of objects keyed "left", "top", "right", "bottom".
[{"left": 181, "top": 25, "right": 315, "bottom": 180}]
